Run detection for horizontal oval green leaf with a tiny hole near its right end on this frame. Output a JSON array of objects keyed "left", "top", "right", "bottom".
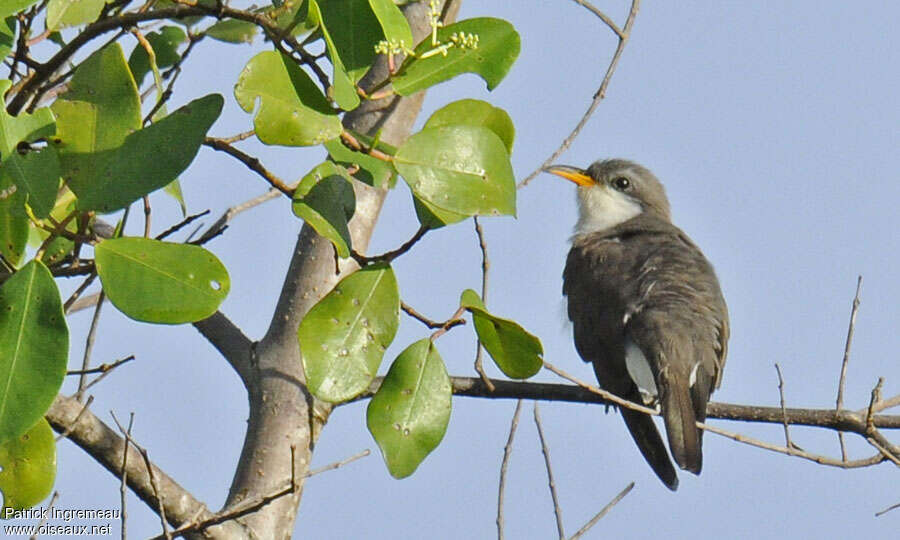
[{"left": 94, "top": 238, "right": 231, "bottom": 324}]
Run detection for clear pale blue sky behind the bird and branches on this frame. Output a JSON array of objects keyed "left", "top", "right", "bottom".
[{"left": 44, "top": 0, "right": 900, "bottom": 539}]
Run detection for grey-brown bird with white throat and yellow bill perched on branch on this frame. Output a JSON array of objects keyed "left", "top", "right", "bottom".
[{"left": 544, "top": 159, "right": 729, "bottom": 491}]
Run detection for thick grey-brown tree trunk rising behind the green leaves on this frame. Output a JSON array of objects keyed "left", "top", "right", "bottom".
[{"left": 226, "top": 2, "right": 458, "bottom": 539}]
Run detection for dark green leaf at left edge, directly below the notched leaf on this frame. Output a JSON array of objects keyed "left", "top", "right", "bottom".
[{"left": 3, "top": 147, "right": 60, "bottom": 218}]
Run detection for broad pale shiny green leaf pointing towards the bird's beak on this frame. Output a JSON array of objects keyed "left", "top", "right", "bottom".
[{"left": 394, "top": 125, "right": 516, "bottom": 216}]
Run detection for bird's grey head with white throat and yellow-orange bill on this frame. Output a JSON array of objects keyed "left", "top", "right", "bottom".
[{"left": 544, "top": 159, "right": 669, "bottom": 235}]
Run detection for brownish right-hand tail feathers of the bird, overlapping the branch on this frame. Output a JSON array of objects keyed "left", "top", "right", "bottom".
[{"left": 660, "top": 372, "right": 708, "bottom": 474}]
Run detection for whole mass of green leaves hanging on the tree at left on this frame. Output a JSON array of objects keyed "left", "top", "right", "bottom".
[{"left": 0, "top": 0, "right": 542, "bottom": 508}]
